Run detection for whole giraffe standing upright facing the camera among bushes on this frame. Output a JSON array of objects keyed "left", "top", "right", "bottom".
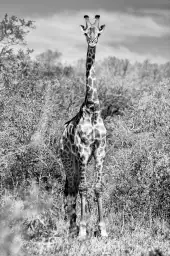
[{"left": 60, "top": 15, "right": 108, "bottom": 239}]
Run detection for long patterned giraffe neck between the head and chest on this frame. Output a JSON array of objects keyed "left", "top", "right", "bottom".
[{"left": 85, "top": 46, "right": 100, "bottom": 111}]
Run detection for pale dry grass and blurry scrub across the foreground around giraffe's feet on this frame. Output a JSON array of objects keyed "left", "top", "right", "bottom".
[{"left": 0, "top": 188, "right": 170, "bottom": 256}]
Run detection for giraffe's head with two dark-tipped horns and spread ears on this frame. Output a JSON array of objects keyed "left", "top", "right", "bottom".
[{"left": 80, "top": 15, "right": 105, "bottom": 47}]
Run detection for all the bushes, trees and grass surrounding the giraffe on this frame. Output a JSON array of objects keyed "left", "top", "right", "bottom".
[{"left": 0, "top": 15, "right": 170, "bottom": 256}]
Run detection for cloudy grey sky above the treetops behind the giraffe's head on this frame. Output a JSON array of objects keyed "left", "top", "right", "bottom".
[{"left": 0, "top": 0, "right": 170, "bottom": 64}]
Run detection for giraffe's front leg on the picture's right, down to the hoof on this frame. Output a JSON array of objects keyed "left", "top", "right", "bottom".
[{"left": 95, "top": 148, "right": 108, "bottom": 237}]
